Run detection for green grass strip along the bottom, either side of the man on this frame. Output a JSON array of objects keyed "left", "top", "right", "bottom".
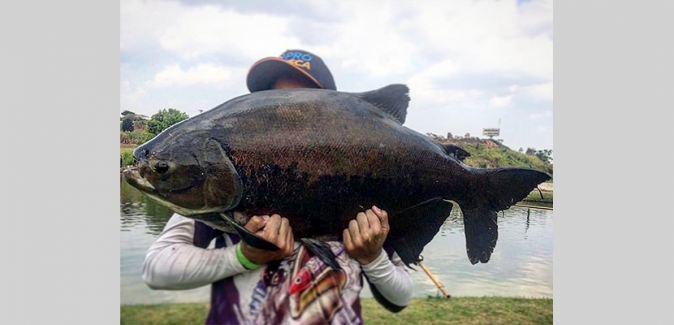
[{"left": 121, "top": 297, "right": 552, "bottom": 325}]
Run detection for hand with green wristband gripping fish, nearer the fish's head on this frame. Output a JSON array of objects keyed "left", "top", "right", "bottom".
[{"left": 241, "top": 214, "right": 295, "bottom": 265}]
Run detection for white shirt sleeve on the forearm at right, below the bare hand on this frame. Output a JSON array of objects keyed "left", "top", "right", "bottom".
[{"left": 362, "top": 250, "right": 413, "bottom": 312}]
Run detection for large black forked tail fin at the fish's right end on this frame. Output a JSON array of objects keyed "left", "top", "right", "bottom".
[{"left": 457, "top": 168, "right": 551, "bottom": 264}]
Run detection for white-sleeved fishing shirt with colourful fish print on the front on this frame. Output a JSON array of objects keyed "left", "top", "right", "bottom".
[{"left": 142, "top": 214, "right": 412, "bottom": 324}]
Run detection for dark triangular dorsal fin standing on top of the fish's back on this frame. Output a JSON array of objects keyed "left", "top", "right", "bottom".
[{"left": 355, "top": 84, "right": 410, "bottom": 124}]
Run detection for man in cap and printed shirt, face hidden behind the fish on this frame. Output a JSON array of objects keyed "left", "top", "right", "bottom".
[{"left": 143, "top": 50, "right": 412, "bottom": 324}]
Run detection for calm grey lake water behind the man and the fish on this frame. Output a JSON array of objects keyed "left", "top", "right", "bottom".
[{"left": 120, "top": 177, "right": 553, "bottom": 305}]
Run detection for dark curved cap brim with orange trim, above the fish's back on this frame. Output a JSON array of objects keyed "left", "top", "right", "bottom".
[{"left": 246, "top": 57, "right": 323, "bottom": 92}]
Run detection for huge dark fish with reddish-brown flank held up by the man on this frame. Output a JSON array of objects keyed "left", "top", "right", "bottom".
[{"left": 125, "top": 85, "right": 550, "bottom": 265}]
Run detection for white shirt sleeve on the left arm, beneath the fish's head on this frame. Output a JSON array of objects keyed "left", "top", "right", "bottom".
[{"left": 142, "top": 214, "right": 246, "bottom": 290}]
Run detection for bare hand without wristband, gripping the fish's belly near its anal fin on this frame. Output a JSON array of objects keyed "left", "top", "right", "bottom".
[{"left": 342, "top": 206, "right": 390, "bottom": 265}]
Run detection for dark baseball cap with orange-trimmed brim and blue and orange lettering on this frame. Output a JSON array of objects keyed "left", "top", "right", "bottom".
[{"left": 246, "top": 50, "right": 337, "bottom": 92}]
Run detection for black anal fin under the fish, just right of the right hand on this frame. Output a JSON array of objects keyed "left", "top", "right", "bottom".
[{"left": 387, "top": 199, "right": 454, "bottom": 268}]
